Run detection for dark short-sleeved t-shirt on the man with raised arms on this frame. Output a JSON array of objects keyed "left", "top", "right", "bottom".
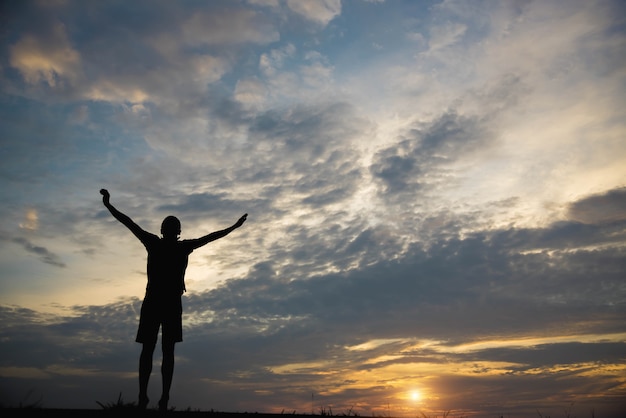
[{"left": 138, "top": 231, "right": 196, "bottom": 298}]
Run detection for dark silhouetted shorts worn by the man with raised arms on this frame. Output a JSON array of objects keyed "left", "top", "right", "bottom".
[{"left": 135, "top": 296, "right": 183, "bottom": 344}]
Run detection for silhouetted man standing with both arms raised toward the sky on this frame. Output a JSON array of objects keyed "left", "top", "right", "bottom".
[{"left": 100, "top": 189, "right": 248, "bottom": 411}]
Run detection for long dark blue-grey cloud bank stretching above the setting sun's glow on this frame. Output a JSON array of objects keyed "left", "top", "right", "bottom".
[{"left": 189, "top": 216, "right": 623, "bottom": 344}]
